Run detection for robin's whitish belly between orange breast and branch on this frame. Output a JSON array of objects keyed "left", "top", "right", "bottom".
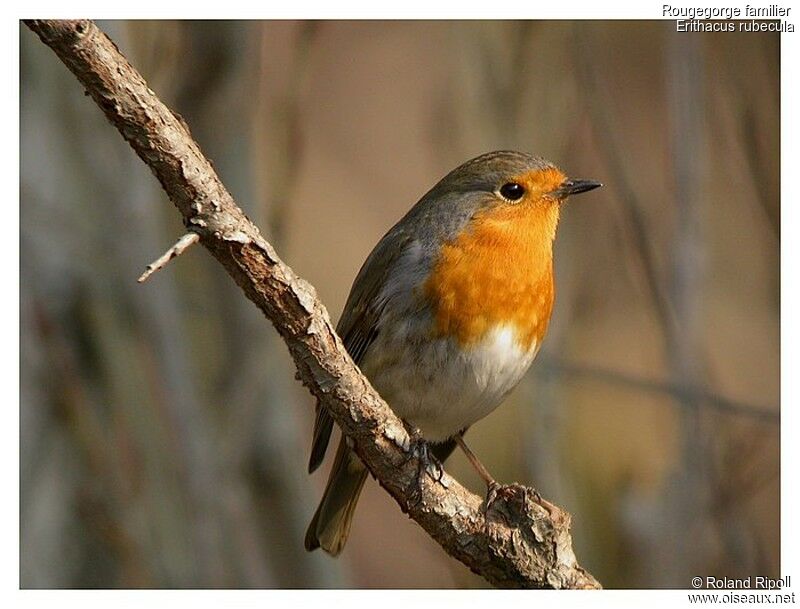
[{"left": 361, "top": 326, "right": 539, "bottom": 442}]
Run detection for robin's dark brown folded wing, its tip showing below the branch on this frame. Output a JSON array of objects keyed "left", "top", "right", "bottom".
[{"left": 308, "top": 228, "right": 409, "bottom": 473}]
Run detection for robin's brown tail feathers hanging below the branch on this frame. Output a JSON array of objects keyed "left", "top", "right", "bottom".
[{"left": 305, "top": 438, "right": 367, "bottom": 556}]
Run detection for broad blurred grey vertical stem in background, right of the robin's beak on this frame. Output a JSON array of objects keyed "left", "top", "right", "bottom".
[{"left": 664, "top": 27, "right": 716, "bottom": 581}]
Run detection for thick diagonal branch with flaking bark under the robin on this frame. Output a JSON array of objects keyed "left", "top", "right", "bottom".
[{"left": 26, "top": 20, "right": 599, "bottom": 588}]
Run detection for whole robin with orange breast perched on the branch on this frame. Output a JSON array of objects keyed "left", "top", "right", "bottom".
[{"left": 305, "top": 151, "right": 601, "bottom": 556}]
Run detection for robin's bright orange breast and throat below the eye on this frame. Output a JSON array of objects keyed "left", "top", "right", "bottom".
[{"left": 425, "top": 202, "right": 559, "bottom": 350}]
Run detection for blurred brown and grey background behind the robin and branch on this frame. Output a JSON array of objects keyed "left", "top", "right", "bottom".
[{"left": 20, "top": 21, "right": 780, "bottom": 588}]
